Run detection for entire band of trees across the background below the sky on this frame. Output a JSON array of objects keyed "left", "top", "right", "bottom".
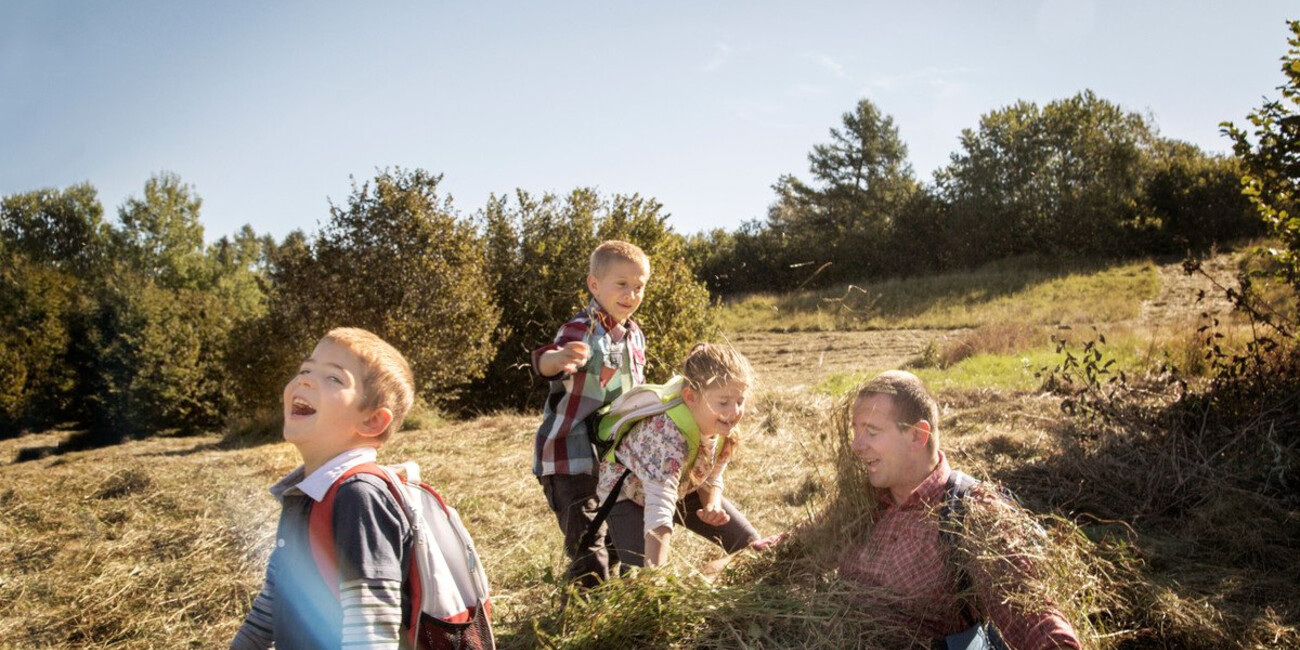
[{"left": 0, "top": 74, "right": 1300, "bottom": 441}]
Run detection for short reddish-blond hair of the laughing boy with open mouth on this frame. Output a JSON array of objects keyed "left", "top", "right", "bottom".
[{"left": 321, "top": 328, "right": 415, "bottom": 443}]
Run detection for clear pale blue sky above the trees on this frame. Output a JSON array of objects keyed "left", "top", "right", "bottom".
[{"left": 0, "top": 0, "right": 1300, "bottom": 241}]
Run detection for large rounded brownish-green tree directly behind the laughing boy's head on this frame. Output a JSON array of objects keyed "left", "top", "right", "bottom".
[{"left": 244, "top": 169, "right": 501, "bottom": 407}]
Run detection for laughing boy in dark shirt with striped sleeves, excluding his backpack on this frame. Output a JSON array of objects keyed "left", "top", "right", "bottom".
[{"left": 230, "top": 328, "right": 415, "bottom": 650}]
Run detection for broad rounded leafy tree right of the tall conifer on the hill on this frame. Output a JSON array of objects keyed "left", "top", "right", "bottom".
[{"left": 937, "top": 91, "right": 1154, "bottom": 264}]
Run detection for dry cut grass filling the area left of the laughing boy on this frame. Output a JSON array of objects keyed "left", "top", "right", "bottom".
[{"left": 0, "top": 434, "right": 289, "bottom": 647}]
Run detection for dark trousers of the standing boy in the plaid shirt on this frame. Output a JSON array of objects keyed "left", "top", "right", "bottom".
[{"left": 538, "top": 475, "right": 618, "bottom": 586}]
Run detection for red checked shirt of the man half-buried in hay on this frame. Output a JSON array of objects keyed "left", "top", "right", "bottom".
[{"left": 840, "top": 452, "right": 1079, "bottom": 650}]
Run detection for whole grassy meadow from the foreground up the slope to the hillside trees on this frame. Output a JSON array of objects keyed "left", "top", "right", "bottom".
[{"left": 0, "top": 255, "right": 1300, "bottom": 649}]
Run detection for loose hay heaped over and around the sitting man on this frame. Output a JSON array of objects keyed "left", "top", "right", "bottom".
[{"left": 540, "top": 392, "right": 1134, "bottom": 650}]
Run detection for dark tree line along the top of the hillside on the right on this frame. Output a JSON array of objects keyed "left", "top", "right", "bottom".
[{"left": 690, "top": 91, "right": 1264, "bottom": 294}]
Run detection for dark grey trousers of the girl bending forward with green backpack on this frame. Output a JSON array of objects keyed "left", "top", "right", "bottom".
[{"left": 608, "top": 491, "right": 758, "bottom": 567}]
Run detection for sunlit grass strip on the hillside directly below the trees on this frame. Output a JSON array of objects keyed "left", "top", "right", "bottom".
[{"left": 719, "top": 260, "right": 1160, "bottom": 332}]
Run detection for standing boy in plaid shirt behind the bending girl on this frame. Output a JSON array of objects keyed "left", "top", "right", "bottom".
[{"left": 533, "top": 241, "right": 650, "bottom": 586}]
